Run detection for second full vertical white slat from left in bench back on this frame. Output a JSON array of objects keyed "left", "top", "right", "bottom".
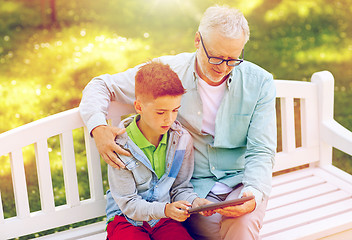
[{"left": 34, "top": 140, "right": 55, "bottom": 212}]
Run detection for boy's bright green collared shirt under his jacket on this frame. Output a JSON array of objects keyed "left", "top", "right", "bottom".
[{"left": 126, "top": 115, "right": 168, "bottom": 178}]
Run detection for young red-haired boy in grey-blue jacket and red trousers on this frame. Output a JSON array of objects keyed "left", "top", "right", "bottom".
[{"left": 107, "top": 62, "right": 207, "bottom": 240}]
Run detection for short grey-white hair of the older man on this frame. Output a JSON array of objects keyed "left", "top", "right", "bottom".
[{"left": 198, "top": 5, "right": 249, "bottom": 42}]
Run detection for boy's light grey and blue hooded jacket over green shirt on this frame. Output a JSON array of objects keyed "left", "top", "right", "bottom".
[{"left": 106, "top": 116, "right": 197, "bottom": 226}]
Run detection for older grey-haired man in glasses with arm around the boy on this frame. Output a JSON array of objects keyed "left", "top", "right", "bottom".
[{"left": 80, "top": 6, "right": 276, "bottom": 240}]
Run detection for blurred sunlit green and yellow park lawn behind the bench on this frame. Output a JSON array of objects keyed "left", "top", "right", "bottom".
[{"left": 0, "top": 0, "right": 352, "bottom": 239}]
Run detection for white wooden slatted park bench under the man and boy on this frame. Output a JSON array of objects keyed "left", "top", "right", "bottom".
[{"left": 0, "top": 71, "right": 352, "bottom": 240}]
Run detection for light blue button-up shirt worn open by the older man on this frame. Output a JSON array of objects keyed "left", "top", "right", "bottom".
[{"left": 80, "top": 53, "right": 276, "bottom": 206}]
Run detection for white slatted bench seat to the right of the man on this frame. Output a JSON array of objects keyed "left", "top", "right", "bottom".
[{"left": 261, "top": 166, "right": 352, "bottom": 240}]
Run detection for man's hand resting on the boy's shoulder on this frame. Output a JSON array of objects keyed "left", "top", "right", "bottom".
[{"left": 92, "top": 125, "right": 131, "bottom": 169}]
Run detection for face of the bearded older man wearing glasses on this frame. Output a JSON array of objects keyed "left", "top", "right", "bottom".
[{"left": 195, "top": 32, "right": 245, "bottom": 86}]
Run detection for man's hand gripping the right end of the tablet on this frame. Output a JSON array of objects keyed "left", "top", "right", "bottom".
[{"left": 215, "top": 192, "right": 256, "bottom": 217}]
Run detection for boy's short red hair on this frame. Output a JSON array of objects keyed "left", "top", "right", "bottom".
[{"left": 135, "top": 61, "right": 186, "bottom": 99}]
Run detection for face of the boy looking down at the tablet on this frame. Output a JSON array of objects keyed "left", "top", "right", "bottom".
[{"left": 135, "top": 95, "right": 182, "bottom": 140}]
